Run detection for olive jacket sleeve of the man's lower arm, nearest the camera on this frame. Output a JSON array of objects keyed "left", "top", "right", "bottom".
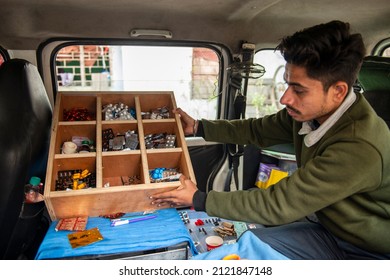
[{"left": 206, "top": 139, "right": 383, "bottom": 225}]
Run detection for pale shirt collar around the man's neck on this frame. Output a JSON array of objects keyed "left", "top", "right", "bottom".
[{"left": 298, "top": 90, "right": 356, "bottom": 147}]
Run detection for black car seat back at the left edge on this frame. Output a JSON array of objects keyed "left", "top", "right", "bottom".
[{"left": 0, "top": 59, "right": 52, "bottom": 259}]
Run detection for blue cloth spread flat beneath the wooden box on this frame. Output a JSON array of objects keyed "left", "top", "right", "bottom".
[{"left": 35, "top": 208, "right": 198, "bottom": 260}]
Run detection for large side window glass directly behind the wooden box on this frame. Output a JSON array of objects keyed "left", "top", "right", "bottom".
[{"left": 56, "top": 45, "right": 220, "bottom": 119}]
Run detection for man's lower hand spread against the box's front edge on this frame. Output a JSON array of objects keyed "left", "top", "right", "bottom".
[{"left": 150, "top": 175, "right": 198, "bottom": 207}]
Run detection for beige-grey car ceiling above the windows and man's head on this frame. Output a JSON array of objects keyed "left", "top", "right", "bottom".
[{"left": 0, "top": 0, "right": 390, "bottom": 51}]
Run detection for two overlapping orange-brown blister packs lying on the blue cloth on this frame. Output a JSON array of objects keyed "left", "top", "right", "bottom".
[{"left": 55, "top": 217, "right": 103, "bottom": 249}]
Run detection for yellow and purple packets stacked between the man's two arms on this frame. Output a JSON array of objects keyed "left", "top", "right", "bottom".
[{"left": 255, "top": 162, "right": 288, "bottom": 189}]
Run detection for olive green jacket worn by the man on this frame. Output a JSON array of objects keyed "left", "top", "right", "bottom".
[{"left": 202, "top": 94, "right": 390, "bottom": 253}]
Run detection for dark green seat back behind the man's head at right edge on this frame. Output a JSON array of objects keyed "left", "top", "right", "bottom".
[{"left": 358, "top": 56, "right": 390, "bottom": 128}]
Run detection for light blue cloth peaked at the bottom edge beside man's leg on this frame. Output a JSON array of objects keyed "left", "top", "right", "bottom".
[{"left": 191, "top": 231, "right": 289, "bottom": 260}]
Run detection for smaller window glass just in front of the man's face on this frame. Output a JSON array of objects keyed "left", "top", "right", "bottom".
[{"left": 245, "top": 50, "right": 286, "bottom": 118}]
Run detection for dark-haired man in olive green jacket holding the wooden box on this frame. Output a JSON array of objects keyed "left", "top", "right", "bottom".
[{"left": 151, "top": 21, "right": 390, "bottom": 259}]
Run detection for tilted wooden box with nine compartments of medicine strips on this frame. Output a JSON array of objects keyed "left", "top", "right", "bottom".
[{"left": 44, "top": 92, "right": 195, "bottom": 220}]
